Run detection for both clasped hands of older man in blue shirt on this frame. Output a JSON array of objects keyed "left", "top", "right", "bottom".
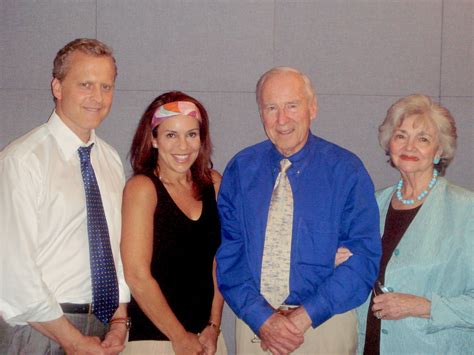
[{"left": 259, "top": 307, "right": 311, "bottom": 355}]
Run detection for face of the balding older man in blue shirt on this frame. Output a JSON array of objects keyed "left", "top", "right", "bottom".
[{"left": 259, "top": 73, "right": 317, "bottom": 157}]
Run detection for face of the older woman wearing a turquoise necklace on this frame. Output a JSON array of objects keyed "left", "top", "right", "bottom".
[{"left": 390, "top": 115, "right": 441, "bottom": 174}]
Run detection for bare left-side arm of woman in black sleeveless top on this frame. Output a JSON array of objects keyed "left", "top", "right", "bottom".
[{"left": 121, "top": 175, "right": 202, "bottom": 354}]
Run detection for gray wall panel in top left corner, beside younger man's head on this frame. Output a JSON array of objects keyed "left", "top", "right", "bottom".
[{"left": 0, "top": 0, "right": 96, "bottom": 89}]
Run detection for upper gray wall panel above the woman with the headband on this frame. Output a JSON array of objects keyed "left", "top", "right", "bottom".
[{"left": 98, "top": 0, "right": 273, "bottom": 92}]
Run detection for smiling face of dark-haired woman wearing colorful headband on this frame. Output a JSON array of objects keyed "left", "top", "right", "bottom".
[{"left": 153, "top": 115, "right": 201, "bottom": 174}]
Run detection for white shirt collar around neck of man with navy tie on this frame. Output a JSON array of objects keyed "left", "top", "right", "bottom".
[{"left": 48, "top": 111, "right": 96, "bottom": 160}]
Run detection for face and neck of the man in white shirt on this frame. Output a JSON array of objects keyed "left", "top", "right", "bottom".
[{"left": 52, "top": 51, "right": 115, "bottom": 142}]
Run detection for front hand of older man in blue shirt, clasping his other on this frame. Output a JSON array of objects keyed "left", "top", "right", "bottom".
[{"left": 259, "top": 313, "right": 304, "bottom": 355}]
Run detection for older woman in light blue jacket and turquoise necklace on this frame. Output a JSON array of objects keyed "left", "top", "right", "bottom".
[{"left": 339, "top": 94, "right": 474, "bottom": 354}]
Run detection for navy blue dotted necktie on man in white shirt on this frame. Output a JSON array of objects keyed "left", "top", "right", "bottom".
[{"left": 78, "top": 144, "right": 119, "bottom": 323}]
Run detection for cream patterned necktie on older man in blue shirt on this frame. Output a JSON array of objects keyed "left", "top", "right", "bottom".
[{"left": 260, "top": 159, "right": 293, "bottom": 308}]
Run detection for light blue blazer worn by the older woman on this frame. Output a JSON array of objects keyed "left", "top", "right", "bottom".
[{"left": 357, "top": 178, "right": 474, "bottom": 355}]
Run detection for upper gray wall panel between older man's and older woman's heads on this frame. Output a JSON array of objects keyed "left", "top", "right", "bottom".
[{"left": 275, "top": 0, "right": 441, "bottom": 96}]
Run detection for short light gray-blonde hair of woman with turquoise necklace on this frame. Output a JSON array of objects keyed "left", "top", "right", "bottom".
[{"left": 379, "top": 94, "right": 457, "bottom": 175}]
